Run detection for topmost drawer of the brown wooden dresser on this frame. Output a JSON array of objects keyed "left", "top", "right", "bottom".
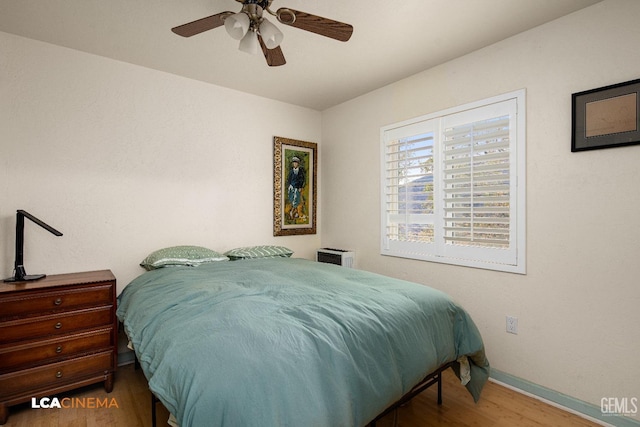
[{"left": 0, "top": 283, "right": 113, "bottom": 319}]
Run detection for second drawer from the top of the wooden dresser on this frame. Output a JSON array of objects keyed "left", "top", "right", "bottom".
[{"left": 0, "top": 306, "right": 114, "bottom": 345}]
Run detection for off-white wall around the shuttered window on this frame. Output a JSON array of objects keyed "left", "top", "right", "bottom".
[{"left": 321, "top": 0, "right": 640, "bottom": 407}]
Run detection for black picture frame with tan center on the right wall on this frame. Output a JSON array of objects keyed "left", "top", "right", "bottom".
[{"left": 571, "top": 79, "right": 640, "bottom": 152}]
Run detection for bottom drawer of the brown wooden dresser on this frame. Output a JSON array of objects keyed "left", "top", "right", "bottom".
[{"left": 0, "top": 351, "right": 114, "bottom": 399}]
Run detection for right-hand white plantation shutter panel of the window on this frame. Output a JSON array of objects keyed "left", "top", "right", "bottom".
[{"left": 441, "top": 100, "right": 517, "bottom": 265}]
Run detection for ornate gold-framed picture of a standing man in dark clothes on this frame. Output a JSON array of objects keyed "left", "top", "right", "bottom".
[{"left": 273, "top": 136, "right": 318, "bottom": 236}]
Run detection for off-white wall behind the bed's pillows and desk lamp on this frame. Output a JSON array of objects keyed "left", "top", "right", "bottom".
[{"left": 0, "top": 32, "right": 321, "bottom": 290}]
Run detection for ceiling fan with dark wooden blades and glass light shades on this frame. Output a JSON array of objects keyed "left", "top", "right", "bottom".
[{"left": 171, "top": 0, "right": 353, "bottom": 67}]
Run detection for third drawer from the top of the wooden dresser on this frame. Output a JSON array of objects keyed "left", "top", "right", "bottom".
[{"left": 0, "top": 327, "right": 114, "bottom": 374}]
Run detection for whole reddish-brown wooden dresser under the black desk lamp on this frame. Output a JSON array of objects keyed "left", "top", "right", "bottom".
[{"left": 0, "top": 270, "right": 118, "bottom": 424}]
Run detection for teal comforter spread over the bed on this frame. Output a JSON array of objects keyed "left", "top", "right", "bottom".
[{"left": 117, "top": 258, "right": 489, "bottom": 427}]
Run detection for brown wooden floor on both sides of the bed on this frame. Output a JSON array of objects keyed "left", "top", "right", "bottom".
[{"left": 5, "top": 365, "right": 597, "bottom": 427}]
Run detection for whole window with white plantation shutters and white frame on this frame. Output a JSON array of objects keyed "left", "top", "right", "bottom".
[{"left": 381, "top": 90, "right": 525, "bottom": 273}]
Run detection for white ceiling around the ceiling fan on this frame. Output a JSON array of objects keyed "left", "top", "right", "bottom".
[{"left": 0, "top": 0, "right": 601, "bottom": 110}]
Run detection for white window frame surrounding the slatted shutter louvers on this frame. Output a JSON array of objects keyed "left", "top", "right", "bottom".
[{"left": 380, "top": 89, "right": 526, "bottom": 274}]
